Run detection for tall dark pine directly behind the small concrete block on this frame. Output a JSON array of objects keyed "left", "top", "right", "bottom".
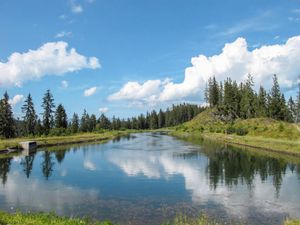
[{"left": 22, "top": 94, "right": 37, "bottom": 135}]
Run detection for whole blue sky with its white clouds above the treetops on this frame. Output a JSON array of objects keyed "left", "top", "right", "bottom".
[{"left": 0, "top": 0, "right": 300, "bottom": 118}]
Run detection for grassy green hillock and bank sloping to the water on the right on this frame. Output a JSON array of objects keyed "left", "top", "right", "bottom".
[{"left": 170, "top": 109, "right": 300, "bottom": 156}]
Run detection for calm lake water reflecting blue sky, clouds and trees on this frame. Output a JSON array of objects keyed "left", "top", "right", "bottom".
[{"left": 0, "top": 134, "right": 300, "bottom": 224}]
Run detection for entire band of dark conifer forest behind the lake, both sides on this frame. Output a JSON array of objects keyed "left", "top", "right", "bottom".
[{"left": 0, "top": 74, "right": 300, "bottom": 138}]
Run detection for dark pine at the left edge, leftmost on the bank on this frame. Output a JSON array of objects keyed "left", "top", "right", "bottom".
[{"left": 0, "top": 92, "right": 15, "bottom": 138}]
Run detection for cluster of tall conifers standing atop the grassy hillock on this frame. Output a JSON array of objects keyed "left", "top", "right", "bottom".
[{"left": 205, "top": 74, "right": 300, "bottom": 123}]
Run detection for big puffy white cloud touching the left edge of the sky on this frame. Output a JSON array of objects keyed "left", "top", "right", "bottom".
[{"left": 0, "top": 41, "right": 100, "bottom": 86}]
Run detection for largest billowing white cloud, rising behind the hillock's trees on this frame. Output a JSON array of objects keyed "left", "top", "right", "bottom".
[{"left": 108, "top": 36, "right": 300, "bottom": 102}]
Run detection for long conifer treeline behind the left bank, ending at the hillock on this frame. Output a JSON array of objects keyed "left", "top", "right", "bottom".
[{"left": 0, "top": 90, "right": 204, "bottom": 138}]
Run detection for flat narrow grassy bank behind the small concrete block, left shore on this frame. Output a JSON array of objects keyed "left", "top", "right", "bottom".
[{"left": 0, "top": 131, "right": 134, "bottom": 151}]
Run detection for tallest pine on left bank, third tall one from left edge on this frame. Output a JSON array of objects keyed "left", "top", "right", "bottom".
[{"left": 42, "top": 89, "right": 55, "bottom": 134}]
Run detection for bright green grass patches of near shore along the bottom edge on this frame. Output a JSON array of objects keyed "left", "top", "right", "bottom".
[{"left": 0, "top": 212, "right": 300, "bottom": 225}]
